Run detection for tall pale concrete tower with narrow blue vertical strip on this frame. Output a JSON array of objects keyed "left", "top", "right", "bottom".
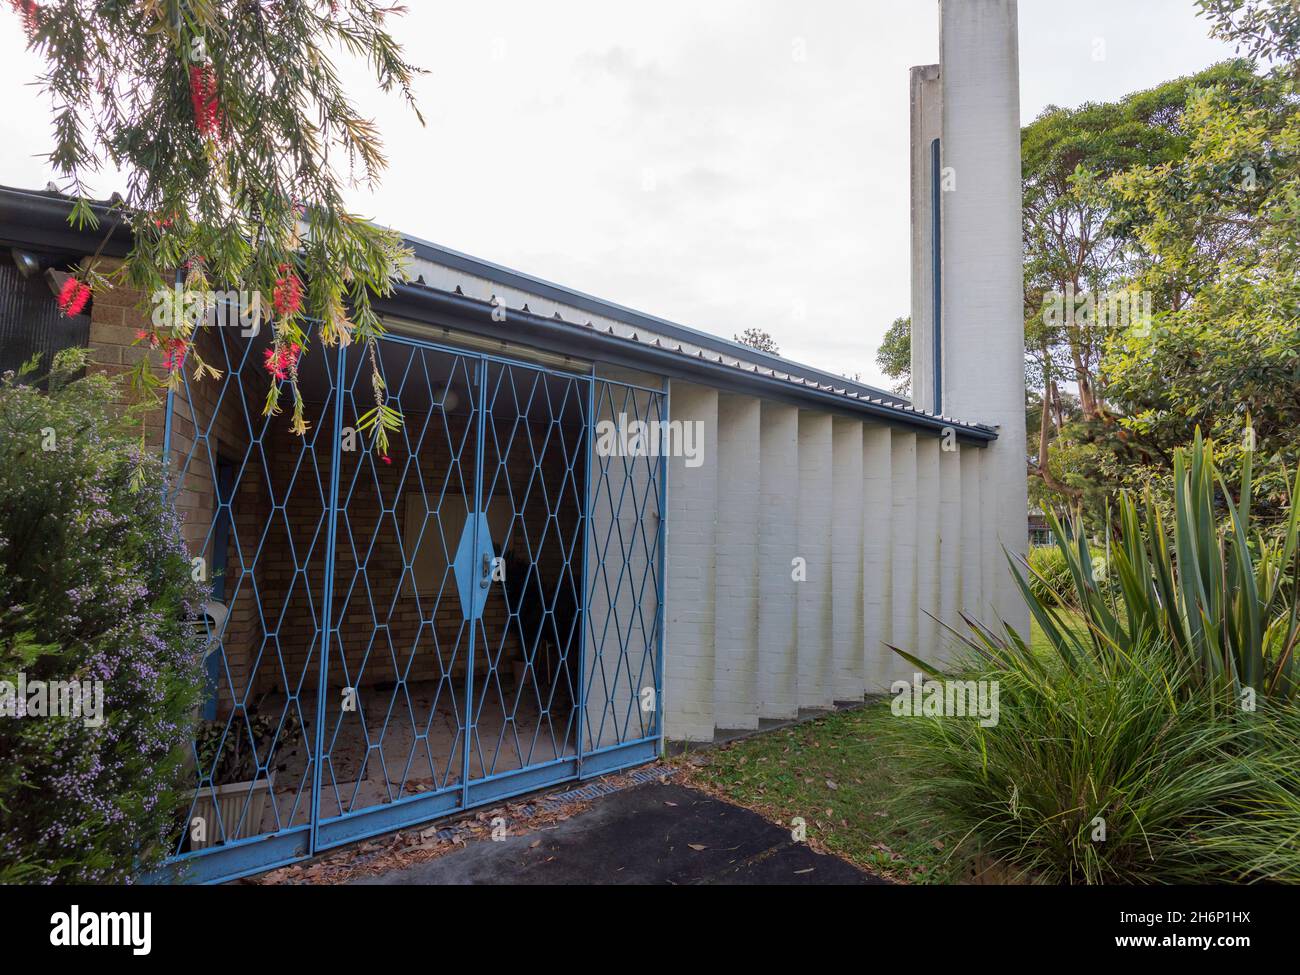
[{"left": 911, "top": 0, "right": 1028, "bottom": 632}]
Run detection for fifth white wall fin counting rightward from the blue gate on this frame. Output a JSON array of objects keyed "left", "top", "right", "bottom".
[{"left": 831, "top": 416, "right": 866, "bottom": 701}]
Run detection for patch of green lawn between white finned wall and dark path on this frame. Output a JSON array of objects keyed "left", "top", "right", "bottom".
[{"left": 676, "top": 625, "right": 1076, "bottom": 883}]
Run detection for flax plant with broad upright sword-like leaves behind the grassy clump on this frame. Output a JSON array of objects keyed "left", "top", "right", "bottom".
[{"left": 1011, "top": 430, "right": 1300, "bottom": 707}]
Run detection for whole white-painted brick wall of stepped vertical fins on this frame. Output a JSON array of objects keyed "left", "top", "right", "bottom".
[{"left": 664, "top": 392, "right": 1002, "bottom": 741}]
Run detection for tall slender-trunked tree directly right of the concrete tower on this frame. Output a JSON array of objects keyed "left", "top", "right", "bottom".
[{"left": 1021, "top": 60, "right": 1256, "bottom": 512}]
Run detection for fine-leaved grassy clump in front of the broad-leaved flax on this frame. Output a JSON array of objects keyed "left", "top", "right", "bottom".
[{"left": 889, "top": 645, "right": 1300, "bottom": 884}]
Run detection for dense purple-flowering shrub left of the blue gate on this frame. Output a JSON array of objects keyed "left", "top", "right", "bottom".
[{"left": 0, "top": 350, "right": 205, "bottom": 883}]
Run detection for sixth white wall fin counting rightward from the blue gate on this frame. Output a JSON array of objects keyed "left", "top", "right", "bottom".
[{"left": 862, "top": 425, "right": 894, "bottom": 693}]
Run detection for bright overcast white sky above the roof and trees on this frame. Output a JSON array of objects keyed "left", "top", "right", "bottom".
[{"left": 0, "top": 0, "right": 1232, "bottom": 384}]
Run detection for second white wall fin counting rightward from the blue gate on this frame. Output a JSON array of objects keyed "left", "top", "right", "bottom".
[{"left": 714, "top": 393, "right": 762, "bottom": 729}]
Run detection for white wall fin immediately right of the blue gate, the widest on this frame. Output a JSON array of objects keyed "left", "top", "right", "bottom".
[{"left": 663, "top": 381, "right": 718, "bottom": 741}]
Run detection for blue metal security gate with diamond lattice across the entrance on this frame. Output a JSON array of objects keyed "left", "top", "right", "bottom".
[{"left": 165, "top": 328, "right": 667, "bottom": 881}]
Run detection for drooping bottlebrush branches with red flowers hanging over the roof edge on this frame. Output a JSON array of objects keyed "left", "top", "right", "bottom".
[{"left": 16, "top": 0, "right": 423, "bottom": 451}]
